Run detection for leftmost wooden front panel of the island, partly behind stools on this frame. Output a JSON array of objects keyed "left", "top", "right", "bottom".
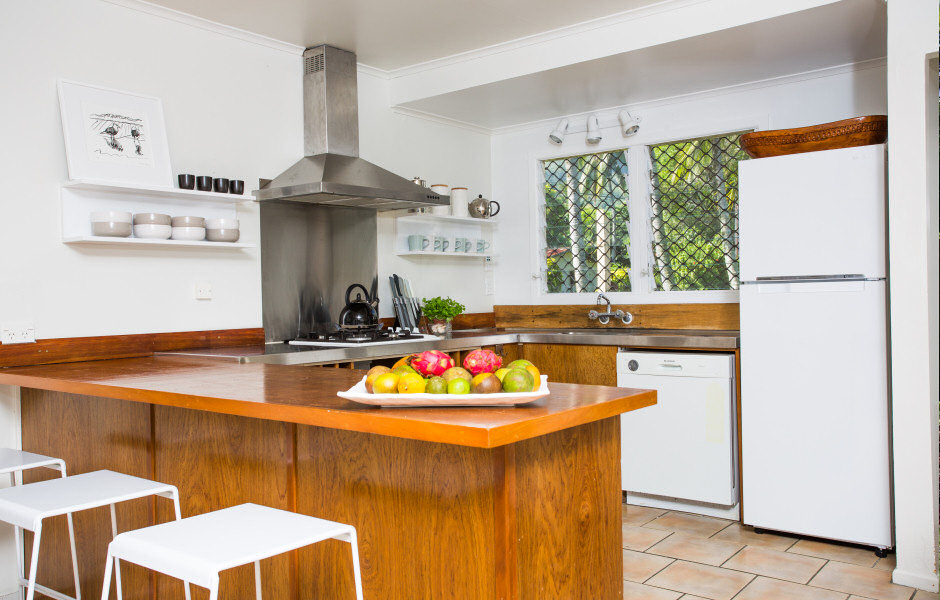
[{"left": 21, "top": 388, "right": 155, "bottom": 600}]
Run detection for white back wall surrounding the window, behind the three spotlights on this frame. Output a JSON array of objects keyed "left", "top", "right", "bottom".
[{"left": 492, "top": 63, "right": 886, "bottom": 304}]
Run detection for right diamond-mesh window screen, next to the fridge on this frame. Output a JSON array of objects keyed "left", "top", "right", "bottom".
[{"left": 649, "top": 133, "right": 747, "bottom": 291}]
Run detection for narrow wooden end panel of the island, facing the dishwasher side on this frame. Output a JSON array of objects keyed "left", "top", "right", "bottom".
[{"left": 515, "top": 416, "right": 623, "bottom": 600}]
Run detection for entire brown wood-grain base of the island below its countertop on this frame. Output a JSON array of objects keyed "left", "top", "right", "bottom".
[{"left": 23, "top": 386, "right": 640, "bottom": 600}]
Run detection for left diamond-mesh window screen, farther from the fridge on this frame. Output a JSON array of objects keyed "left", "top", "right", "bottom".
[{"left": 542, "top": 151, "right": 630, "bottom": 293}]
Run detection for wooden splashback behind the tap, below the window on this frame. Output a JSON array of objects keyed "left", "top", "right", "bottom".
[{"left": 493, "top": 303, "right": 740, "bottom": 330}]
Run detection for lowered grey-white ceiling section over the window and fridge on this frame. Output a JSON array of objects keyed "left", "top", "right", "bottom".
[{"left": 401, "top": 0, "right": 887, "bottom": 129}]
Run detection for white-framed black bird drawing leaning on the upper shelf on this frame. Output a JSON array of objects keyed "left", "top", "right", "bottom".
[{"left": 59, "top": 80, "right": 173, "bottom": 187}]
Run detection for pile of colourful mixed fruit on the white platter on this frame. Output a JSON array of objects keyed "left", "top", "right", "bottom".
[{"left": 365, "top": 350, "right": 541, "bottom": 394}]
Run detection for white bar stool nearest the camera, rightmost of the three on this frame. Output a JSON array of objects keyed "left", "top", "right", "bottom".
[{"left": 101, "top": 504, "right": 362, "bottom": 600}]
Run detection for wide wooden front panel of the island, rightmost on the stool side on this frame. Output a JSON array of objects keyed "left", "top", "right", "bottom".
[{"left": 297, "top": 425, "right": 496, "bottom": 600}]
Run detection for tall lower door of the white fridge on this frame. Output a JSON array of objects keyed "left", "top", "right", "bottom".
[{"left": 741, "top": 281, "right": 893, "bottom": 547}]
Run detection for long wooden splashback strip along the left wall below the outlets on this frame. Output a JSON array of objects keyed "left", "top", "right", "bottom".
[{"left": 0, "top": 328, "right": 264, "bottom": 367}]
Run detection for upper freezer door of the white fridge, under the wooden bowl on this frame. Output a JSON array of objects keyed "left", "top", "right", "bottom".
[{"left": 738, "top": 145, "right": 885, "bottom": 281}]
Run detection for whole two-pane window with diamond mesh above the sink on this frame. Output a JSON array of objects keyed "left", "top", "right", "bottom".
[{"left": 542, "top": 133, "right": 747, "bottom": 294}]
